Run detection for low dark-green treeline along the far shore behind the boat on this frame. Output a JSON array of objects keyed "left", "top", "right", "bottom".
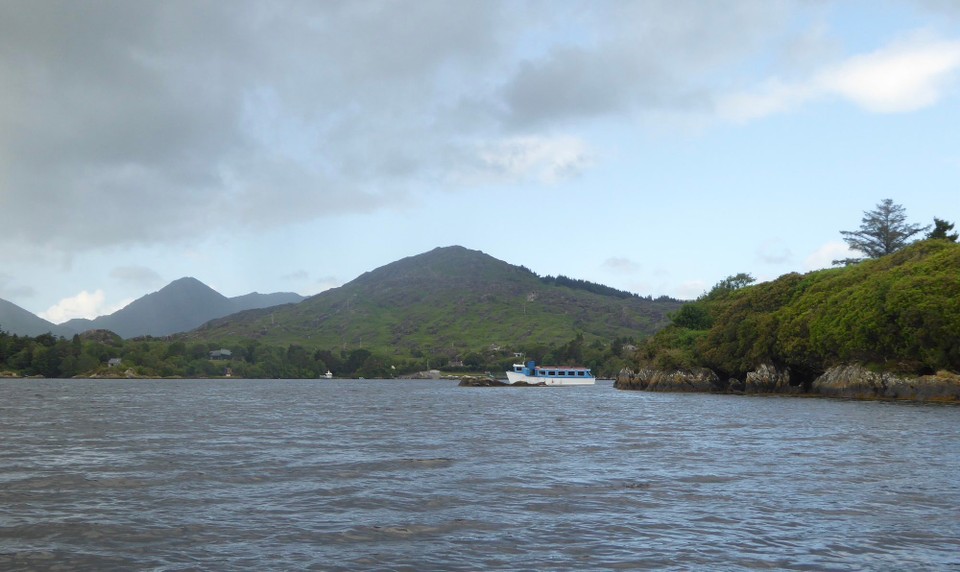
[{"left": 0, "top": 330, "right": 635, "bottom": 379}]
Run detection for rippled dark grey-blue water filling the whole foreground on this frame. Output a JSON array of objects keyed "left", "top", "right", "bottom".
[{"left": 0, "top": 380, "right": 960, "bottom": 571}]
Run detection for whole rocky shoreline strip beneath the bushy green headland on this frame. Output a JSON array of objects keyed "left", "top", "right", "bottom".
[{"left": 613, "top": 364, "right": 960, "bottom": 403}]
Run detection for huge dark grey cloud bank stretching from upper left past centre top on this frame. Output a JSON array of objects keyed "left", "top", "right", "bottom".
[{"left": 0, "top": 0, "right": 796, "bottom": 252}]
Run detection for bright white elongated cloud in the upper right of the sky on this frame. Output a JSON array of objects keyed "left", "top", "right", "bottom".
[{"left": 717, "top": 34, "right": 960, "bottom": 121}]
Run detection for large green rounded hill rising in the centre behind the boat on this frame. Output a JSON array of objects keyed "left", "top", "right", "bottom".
[{"left": 186, "top": 246, "right": 681, "bottom": 356}]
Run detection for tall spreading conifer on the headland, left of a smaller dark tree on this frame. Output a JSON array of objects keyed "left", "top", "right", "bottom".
[{"left": 833, "top": 199, "right": 930, "bottom": 266}]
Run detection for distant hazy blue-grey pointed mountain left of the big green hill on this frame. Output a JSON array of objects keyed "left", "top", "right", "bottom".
[{"left": 63, "top": 277, "right": 303, "bottom": 338}]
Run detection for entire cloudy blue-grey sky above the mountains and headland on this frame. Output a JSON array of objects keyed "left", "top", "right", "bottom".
[{"left": 0, "top": 0, "right": 960, "bottom": 323}]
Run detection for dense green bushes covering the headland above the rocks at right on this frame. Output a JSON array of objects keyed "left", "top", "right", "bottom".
[{"left": 636, "top": 239, "right": 960, "bottom": 379}]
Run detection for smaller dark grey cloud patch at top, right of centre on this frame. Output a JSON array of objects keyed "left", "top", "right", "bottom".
[{"left": 503, "top": 0, "right": 788, "bottom": 127}]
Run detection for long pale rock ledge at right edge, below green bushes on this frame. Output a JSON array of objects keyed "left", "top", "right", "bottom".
[{"left": 813, "top": 365, "right": 960, "bottom": 401}]
